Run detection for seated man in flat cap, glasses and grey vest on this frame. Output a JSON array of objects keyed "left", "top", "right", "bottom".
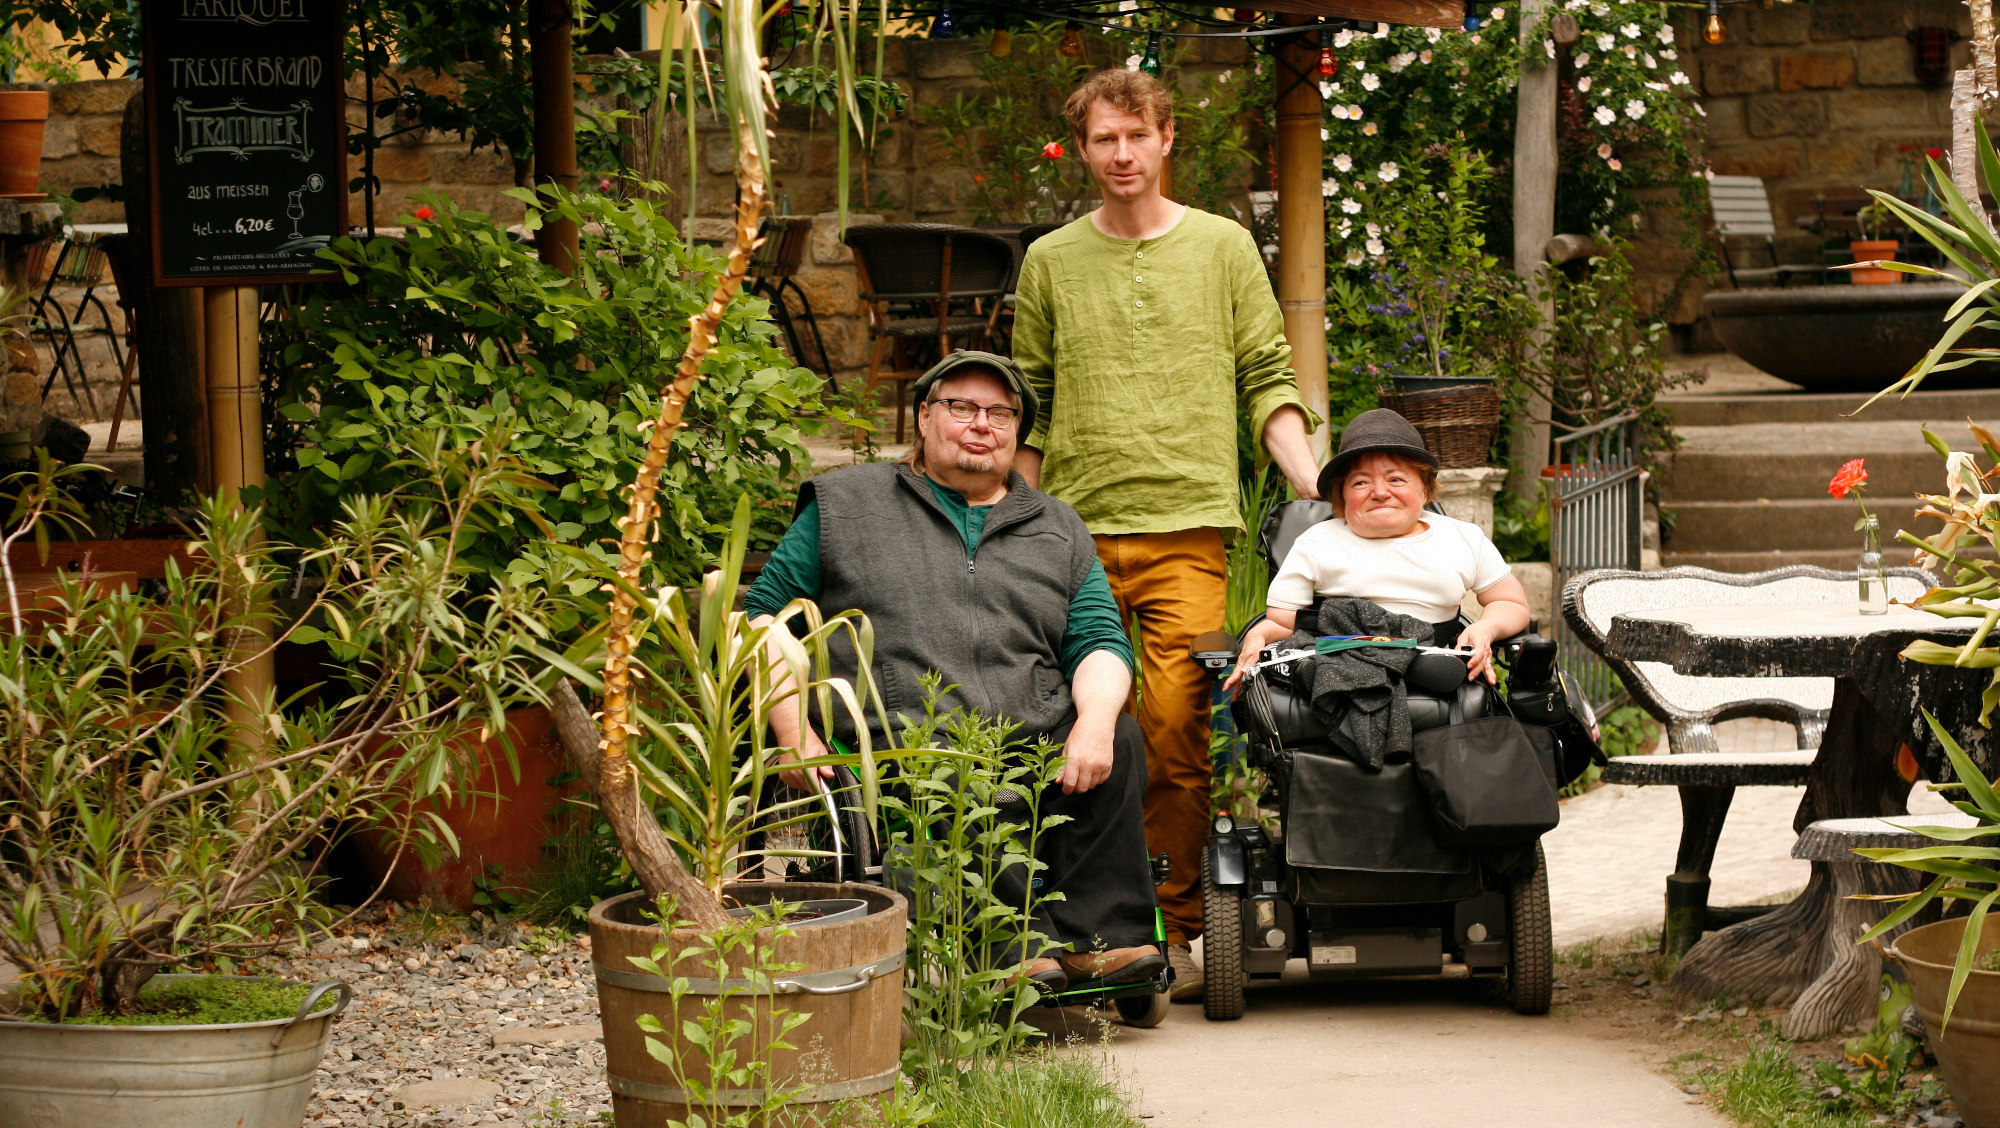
[{"left": 744, "top": 350, "right": 1164, "bottom": 990}]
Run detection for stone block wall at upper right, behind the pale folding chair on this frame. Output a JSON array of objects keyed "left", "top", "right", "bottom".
[{"left": 1688, "top": 0, "right": 1972, "bottom": 262}]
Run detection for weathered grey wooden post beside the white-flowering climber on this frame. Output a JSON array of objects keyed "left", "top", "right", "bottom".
[{"left": 1508, "top": 0, "right": 1556, "bottom": 502}]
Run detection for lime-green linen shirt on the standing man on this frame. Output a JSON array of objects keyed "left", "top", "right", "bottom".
[{"left": 1014, "top": 208, "right": 1318, "bottom": 534}]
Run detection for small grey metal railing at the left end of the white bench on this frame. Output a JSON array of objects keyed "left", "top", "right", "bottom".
[{"left": 1548, "top": 414, "right": 1646, "bottom": 706}]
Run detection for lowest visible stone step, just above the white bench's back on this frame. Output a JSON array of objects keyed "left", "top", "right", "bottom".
[{"left": 1660, "top": 498, "right": 1938, "bottom": 556}]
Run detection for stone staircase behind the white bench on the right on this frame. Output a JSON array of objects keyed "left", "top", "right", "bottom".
[{"left": 1660, "top": 376, "right": 2000, "bottom": 572}]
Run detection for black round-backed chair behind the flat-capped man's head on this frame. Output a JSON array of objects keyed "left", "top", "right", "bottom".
[{"left": 846, "top": 224, "right": 1014, "bottom": 442}]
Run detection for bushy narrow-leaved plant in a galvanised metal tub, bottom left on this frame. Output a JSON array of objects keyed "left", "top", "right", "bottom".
[{"left": 0, "top": 434, "right": 572, "bottom": 1128}]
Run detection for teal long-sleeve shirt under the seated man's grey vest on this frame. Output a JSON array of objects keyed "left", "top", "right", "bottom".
[{"left": 744, "top": 482, "right": 1132, "bottom": 678}]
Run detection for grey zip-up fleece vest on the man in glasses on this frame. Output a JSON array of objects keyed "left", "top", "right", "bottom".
[{"left": 800, "top": 462, "right": 1098, "bottom": 740}]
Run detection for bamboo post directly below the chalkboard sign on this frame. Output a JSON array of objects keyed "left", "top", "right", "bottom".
[{"left": 202, "top": 286, "right": 274, "bottom": 756}]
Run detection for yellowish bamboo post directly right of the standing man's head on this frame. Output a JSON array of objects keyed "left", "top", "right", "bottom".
[{"left": 1274, "top": 16, "right": 1330, "bottom": 460}]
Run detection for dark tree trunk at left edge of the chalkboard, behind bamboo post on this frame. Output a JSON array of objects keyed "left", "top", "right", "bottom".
[{"left": 120, "top": 94, "right": 210, "bottom": 506}]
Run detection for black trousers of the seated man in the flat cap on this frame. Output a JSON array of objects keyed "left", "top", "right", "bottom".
[{"left": 994, "top": 712, "right": 1158, "bottom": 952}]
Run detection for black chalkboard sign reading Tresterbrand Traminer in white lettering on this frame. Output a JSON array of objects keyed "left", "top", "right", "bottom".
[{"left": 140, "top": 0, "right": 348, "bottom": 286}]
